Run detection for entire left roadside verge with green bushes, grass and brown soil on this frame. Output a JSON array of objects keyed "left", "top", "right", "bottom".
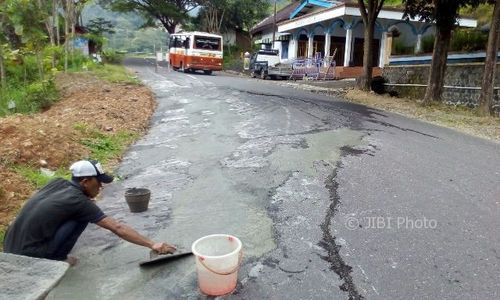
[{"left": 0, "top": 0, "right": 154, "bottom": 248}]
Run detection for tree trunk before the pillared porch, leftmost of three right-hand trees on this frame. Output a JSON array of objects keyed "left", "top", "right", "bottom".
[{"left": 358, "top": 0, "right": 384, "bottom": 91}]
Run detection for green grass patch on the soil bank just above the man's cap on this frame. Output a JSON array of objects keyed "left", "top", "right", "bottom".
[{"left": 74, "top": 123, "right": 138, "bottom": 163}]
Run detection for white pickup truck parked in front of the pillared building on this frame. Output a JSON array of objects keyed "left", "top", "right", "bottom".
[{"left": 250, "top": 50, "right": 292, "bottom": 79}]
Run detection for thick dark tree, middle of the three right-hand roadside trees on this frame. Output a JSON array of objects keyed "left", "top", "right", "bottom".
[{"left": 403, "top": 0, "right": 482, "bottom": 105}]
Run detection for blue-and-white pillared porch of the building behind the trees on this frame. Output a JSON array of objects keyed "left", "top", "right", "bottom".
[{"left": 264, "top": 1, "right": 477, "bottom": 68}]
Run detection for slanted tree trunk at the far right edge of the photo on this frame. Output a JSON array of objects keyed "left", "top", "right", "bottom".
[{"left": 478, "top": 0, "right": 500, "bottom": 116}]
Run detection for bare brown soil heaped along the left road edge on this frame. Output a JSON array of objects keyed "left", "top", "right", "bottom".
[{"left": 0, "top": 73, "right": 156, "bottom": 230}]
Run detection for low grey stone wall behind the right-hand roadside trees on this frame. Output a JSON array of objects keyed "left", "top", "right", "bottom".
[{"left": 382, "top": 63, "right": 500, "bottom": 107}]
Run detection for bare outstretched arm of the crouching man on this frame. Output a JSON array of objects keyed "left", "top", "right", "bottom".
[{"left": 96, "top": 217, "right": 176, "bottom": 254}]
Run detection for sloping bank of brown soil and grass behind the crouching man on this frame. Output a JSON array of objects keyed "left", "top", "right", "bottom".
[{"left": 0, "top": 63, "right": 154, "bottom": 249}]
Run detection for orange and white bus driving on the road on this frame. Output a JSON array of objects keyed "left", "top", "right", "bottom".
[{"left": 169, "top": 32, "right": 223, "bottom": 75}]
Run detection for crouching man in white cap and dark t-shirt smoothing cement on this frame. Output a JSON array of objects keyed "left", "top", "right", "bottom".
[{"left": 3, "top": 160, "right": 176, "bottom": 265}]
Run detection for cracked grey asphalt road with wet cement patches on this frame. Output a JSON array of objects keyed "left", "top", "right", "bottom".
[{"left": 48, "top": 60, "right": 500, "bottom": 299}]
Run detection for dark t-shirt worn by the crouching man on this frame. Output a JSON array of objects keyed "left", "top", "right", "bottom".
[{"left": 4, "top": 178, "right": 106, "bottom": 257}]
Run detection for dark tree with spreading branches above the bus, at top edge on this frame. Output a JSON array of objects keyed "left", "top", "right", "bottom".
[{"left": 99, "top": 0, "right": 198, "bottom": 33}]
